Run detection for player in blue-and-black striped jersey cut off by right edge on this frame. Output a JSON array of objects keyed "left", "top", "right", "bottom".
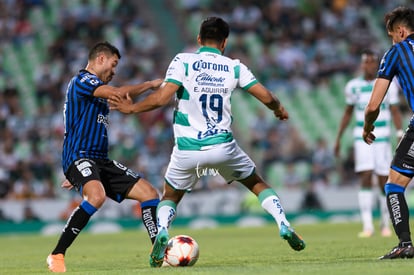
[{"left": 362, "top": 7, "right": 414, "bottom": 259}]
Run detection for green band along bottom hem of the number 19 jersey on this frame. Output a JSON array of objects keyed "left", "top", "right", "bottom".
[{"left": 177, "top": 133, "right": 233, "bottom": 151}]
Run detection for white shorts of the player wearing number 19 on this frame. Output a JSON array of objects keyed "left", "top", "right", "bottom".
[{"left": 165, "top": 140, "right": 256, "bottom": 190}]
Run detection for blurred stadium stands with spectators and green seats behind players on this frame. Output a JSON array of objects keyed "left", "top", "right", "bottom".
[{"left": 0, "top": 0, "right": 409, "bottom": 220}]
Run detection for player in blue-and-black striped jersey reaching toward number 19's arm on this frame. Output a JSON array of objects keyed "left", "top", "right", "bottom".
[{"left": 47, "top": 42, "right": 162, "bottom": 272}]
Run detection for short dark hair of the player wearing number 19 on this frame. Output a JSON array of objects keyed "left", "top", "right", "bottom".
[{"left": 199, "top": 17, "right": 230, "bottom": 43}]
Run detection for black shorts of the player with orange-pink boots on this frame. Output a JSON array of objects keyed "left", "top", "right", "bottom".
[{"left": 65, "top": 158, "right": 141, "bottom": 202}]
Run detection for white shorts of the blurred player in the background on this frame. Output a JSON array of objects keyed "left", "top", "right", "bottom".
[{"left": 354, "top": 140, "right": 392, "bottom": 176}]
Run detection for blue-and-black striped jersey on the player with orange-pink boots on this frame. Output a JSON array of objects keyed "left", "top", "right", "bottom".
[{"left": 62, "top": 70, "right": 109, "bottom": 172}]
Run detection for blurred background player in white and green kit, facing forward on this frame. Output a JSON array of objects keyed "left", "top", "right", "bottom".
[{"left": 334, "top": 49, "right": 403, "bottom": 238}]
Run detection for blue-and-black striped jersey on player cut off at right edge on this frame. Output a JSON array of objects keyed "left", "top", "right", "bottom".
[{"left": 377, "top": 35, "right": 414, "bottom": 114}]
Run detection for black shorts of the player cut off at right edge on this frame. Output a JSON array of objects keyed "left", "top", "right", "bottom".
[{"left": 391, "top": 125, "right": 414, "bottom": 178}]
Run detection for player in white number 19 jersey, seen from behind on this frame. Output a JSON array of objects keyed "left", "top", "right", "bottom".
[{"left": 110, "top": 17, "right": 305, "bottom": 267}]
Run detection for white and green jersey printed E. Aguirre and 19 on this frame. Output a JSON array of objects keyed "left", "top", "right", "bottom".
[{"left": 165, "top": 47, "right": 257, "bottom": 151}]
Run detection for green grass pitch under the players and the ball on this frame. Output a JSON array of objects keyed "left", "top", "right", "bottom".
[{"left": 0, "top": 223, "right": 414, "bottom": 275}]
